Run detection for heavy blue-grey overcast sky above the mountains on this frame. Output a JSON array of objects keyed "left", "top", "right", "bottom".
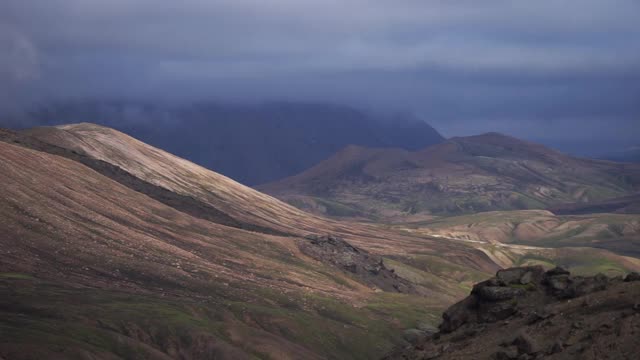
[{"left": 0, "top": 0, "right": 640, "bottom": 152}]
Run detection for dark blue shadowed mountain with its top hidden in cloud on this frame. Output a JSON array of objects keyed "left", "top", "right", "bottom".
[{"left": 11, "top": 102, "right": 444, "bottom": 185}]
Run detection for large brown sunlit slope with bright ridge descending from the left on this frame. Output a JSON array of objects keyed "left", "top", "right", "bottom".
[{"left": 0, "top": 123, "right": 640, "bottom": 359}]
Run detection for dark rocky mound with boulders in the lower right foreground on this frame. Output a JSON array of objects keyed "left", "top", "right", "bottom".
[{"left": 385, "top": 266, "right": 640, "bottom": 360}]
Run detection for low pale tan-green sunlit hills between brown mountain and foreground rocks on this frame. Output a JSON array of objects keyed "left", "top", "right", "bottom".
[{"left": 393, "top": 210, "right": 640, "bottom": 266}]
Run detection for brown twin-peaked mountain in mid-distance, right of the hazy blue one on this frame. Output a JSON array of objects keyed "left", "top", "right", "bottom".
[{"left": 259, "top": 133, "right": 640, "bottom": 221}]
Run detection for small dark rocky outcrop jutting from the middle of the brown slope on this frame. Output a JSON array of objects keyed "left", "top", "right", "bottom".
[{"left": 300, "top": 235, "right": 415, "bottom": 293}]
